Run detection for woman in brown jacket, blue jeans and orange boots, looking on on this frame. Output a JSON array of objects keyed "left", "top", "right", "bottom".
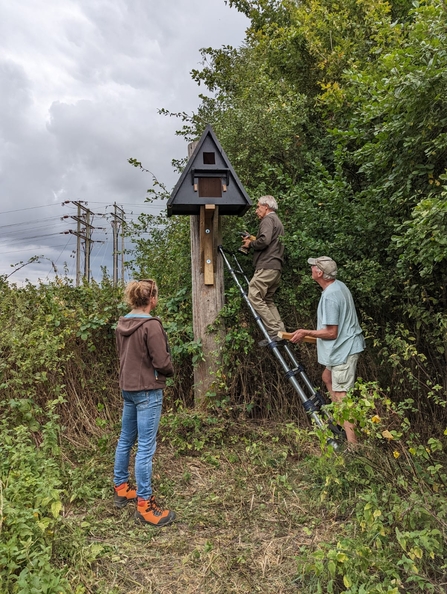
[{"left": 114, "top": 279, "right": 175, "bottom": 526}]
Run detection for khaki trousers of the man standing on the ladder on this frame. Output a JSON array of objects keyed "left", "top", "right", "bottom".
[{"left": 248, "top": 268, "right": 286, "bottom": 337}]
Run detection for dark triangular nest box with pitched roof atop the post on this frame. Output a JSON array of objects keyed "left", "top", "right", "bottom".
[{"left": 167, "top": 126, "right": 252, "bottom": 217}]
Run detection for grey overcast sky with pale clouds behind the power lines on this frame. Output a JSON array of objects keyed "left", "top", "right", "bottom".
[{"left": 0, "top": 0, "right": 248, "bottom": 284}]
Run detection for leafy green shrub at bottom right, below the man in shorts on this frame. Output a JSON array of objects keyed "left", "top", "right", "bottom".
[{"left": 297, "top": 384, "right": 447, "bottom": 594}]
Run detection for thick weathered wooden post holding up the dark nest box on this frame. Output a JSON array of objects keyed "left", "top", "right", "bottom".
[{"left": 188, "top": 141, "right": 224, "bottom": 407}]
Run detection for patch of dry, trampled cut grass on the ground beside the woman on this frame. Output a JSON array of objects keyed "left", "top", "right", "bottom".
[{"left": 65, "top": 418, "right": 337, "bottom": 594}]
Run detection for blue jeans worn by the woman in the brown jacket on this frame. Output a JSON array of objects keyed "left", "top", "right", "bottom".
[{"left": 113, "top": 390, "right": 163, "bottom": 499}]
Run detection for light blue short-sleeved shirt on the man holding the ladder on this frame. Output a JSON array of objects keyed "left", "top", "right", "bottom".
[{"left": 317, "top": 280, "right": 365, "bottom": 366}]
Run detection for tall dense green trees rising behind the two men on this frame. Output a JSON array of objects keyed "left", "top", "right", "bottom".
[{"left": 148, "top": 0, "right": 447, "bottom": 422}]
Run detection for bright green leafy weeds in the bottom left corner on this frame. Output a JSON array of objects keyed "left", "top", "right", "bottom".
[{"left": 0, "top": 402, "right": 71, "bottom": 594}]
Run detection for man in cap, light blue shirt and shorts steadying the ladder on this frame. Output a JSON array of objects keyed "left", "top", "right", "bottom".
[{"left": 291, "top": 256, "right": 365, "bottom": 443}]
